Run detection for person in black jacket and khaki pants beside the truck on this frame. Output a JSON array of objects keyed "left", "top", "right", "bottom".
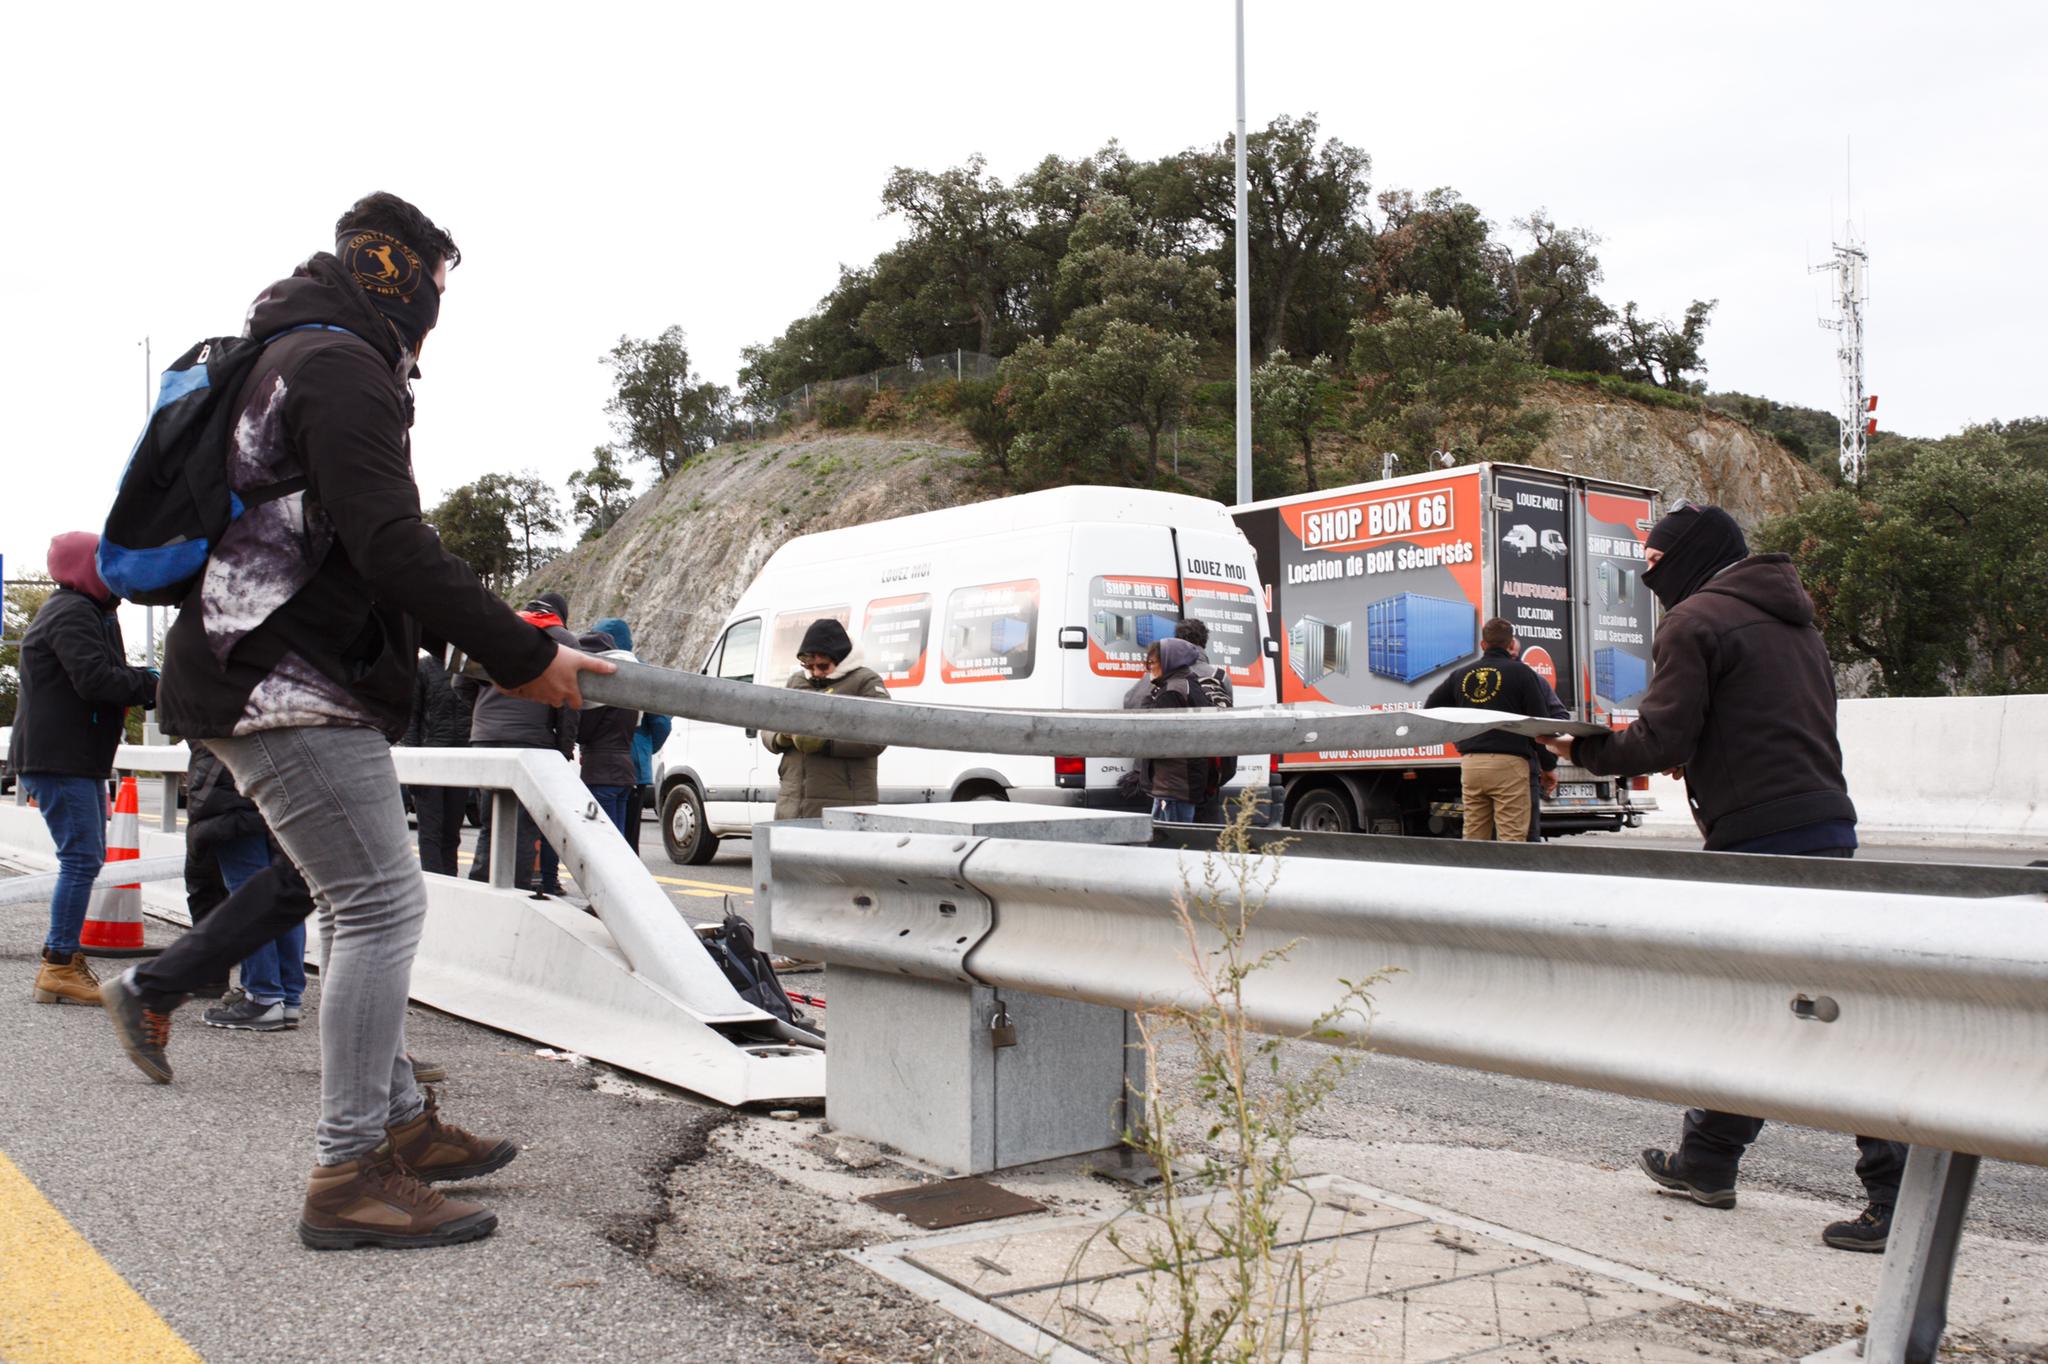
[{"left": 1423, "top": 616, "right": 1556, "bottom": 844}]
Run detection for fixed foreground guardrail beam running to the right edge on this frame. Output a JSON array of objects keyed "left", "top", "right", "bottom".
[{"left": 768, "top": 825, "right": 2048, "bottom": 1165}]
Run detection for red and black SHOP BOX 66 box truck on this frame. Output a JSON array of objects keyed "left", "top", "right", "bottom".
[{"left": 1233, "top": 463, "right": 1657, "bottom": 834}]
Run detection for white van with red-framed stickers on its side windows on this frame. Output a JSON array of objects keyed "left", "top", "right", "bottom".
[{"left": 653, "top": 487, "right": 1278, "bottom": 864}]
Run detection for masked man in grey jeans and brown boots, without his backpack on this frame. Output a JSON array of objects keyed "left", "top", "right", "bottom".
[{"left": 102, "top": 195, "right": 612, "bottom": 1249}]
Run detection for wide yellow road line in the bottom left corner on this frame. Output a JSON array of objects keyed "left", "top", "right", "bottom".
[{"left": 0, "top": 1155, "right": 203, "bottom": 1364}]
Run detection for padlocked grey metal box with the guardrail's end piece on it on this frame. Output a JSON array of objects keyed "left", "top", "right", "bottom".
[{"left": 754, "top": 801, "right": 1151, "bottom": 1174}]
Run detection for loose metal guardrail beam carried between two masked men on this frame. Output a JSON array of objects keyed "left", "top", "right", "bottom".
[{"left": 503, "top": 657, "right": 1608, "bottom": 758}]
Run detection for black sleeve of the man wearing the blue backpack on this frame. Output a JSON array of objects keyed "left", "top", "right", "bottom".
[{"left": 285, "top": 346, "right": 555, "bottom": 686}]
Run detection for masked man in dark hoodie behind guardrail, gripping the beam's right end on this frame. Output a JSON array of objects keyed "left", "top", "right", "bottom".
[{"left": 1544, "top": 504, "right": 1907, "bottom": 1251}]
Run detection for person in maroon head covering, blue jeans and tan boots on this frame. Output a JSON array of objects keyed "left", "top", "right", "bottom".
[{"left": 8, "top": 530, "right": 156, "bottom": 1004}]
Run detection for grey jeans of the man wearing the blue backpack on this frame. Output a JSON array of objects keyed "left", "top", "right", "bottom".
[{"left": 207, "top": 727, "right": 426, "bottom": 1165}]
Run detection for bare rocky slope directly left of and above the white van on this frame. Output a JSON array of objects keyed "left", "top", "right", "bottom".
[{"left": 514, "top": 430, "right": 991, "bottom": 668}]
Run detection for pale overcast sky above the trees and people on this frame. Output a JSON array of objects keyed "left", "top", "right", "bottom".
[{"left": 0, "top": 0, "right": 2048, "bottom": 622}]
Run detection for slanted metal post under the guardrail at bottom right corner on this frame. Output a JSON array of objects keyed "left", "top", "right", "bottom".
[{"left": 1864, "top": 1147, "right": 1978, "bottom": 1364}]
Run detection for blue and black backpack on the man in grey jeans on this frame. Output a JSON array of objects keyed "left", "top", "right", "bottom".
[{"left": 98, "top": 324, "right": 346, "bottom": 606}]
